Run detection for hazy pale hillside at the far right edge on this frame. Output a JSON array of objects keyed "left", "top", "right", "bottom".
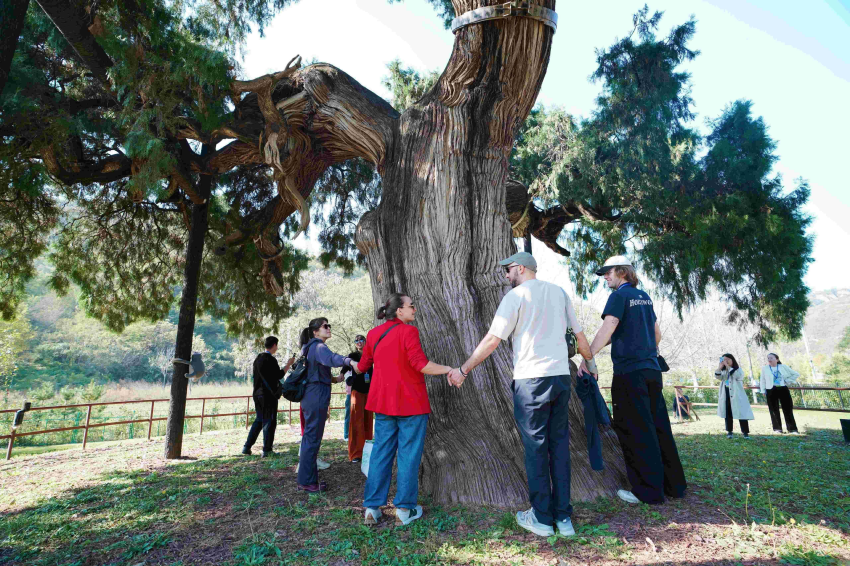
[{"left": 783, "top": 289, "right": 850, "bottom": 357}]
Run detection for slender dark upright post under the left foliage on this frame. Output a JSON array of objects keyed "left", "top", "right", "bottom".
[{"left": 165, "top": 150, "right": 213, "bottom": 459}]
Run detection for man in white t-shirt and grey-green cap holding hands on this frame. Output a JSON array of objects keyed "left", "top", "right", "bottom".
[{"left": 449, "top": 252, "right": 596, "bottom": 536}]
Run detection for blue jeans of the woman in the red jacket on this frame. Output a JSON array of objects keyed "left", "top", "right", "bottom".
[{"left": 363, "top": 413, "right": 428, "bottom": 509}]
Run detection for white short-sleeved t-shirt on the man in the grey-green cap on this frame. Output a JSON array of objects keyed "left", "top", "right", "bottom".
[{"left": 489, "top": 279, "right": 582, "bottom": 379}]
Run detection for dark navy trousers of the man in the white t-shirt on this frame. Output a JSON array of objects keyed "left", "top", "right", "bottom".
[{"left": 512, "top": 375, "right": 573, "bottom": 525}]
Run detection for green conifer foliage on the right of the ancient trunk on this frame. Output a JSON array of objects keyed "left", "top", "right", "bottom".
[{"left": 512, "top": 8, "right": 812, "bottom": 342}]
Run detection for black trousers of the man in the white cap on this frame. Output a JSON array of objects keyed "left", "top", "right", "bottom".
[{"left": 611, "top": 369, "right": 687, "bottom": 503}]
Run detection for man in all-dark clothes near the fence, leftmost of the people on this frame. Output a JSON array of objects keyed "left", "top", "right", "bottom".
[{"left": 242, "top": 336, "right": 295, "bottom": 458}]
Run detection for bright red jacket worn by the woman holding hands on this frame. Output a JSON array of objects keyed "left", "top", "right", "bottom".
[{"left": 357, "top": 320, "right": 431, "bottom": 417}]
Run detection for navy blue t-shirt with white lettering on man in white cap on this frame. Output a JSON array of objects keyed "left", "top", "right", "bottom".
[{"left": 602, "top": 283, "right": 661, "bottom": 375}]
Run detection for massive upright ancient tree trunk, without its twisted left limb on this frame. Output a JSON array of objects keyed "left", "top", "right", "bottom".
[{"left": 358, "top": 0, "right": 626, "bottom": 506}]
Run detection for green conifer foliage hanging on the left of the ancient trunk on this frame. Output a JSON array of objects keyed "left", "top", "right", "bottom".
[{"left": 0, "top": 0, "right": 307, "bottom": 333}]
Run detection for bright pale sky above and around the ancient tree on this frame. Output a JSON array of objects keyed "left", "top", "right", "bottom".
[{"left": 238, "top": 0, "right": 850, "bottom": 291}]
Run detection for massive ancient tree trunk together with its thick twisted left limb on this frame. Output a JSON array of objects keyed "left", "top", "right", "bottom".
[{"left": 213, "top": 0, "right": 626, "bottom": 506}]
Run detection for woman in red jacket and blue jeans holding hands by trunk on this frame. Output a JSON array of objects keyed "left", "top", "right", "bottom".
[{"left": 356, "top": 293, "right": 452, "bottom": 525}]
